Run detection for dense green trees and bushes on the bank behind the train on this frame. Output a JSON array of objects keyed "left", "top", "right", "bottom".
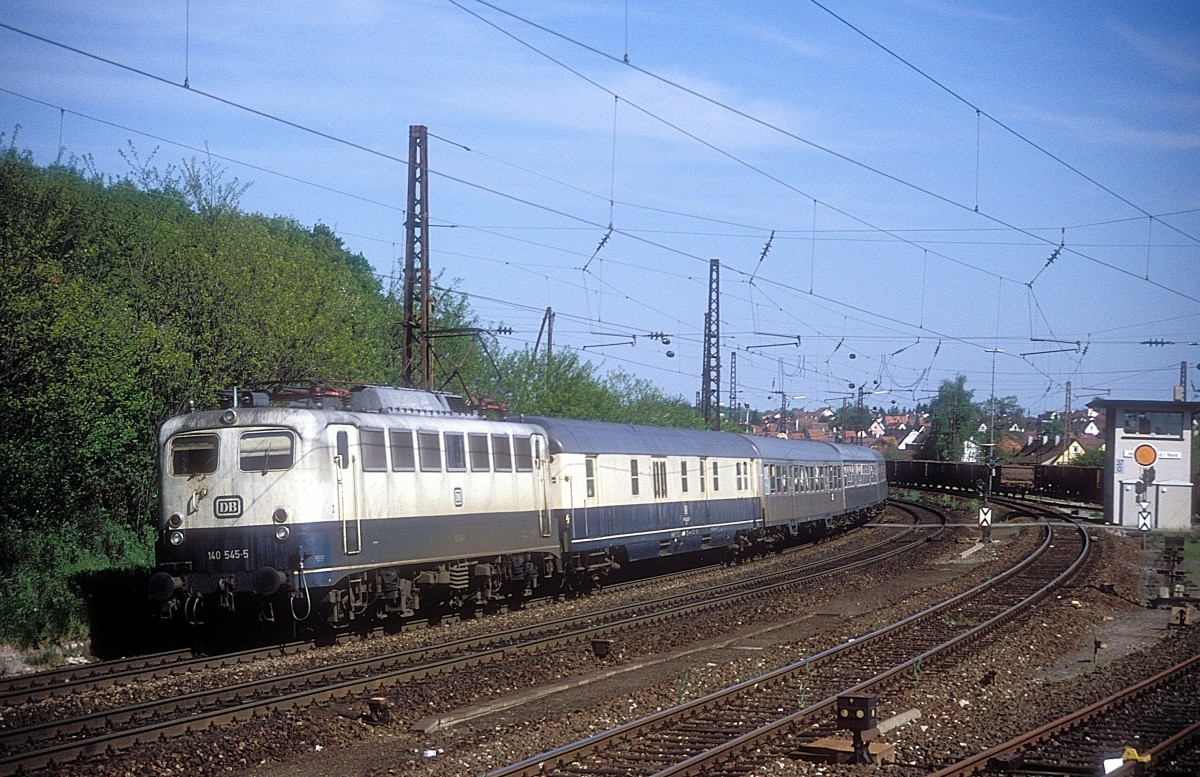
[{"left": 0, "top": 134, "right": 700, "bottom": 645}]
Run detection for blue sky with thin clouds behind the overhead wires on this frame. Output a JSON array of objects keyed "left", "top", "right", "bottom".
[{"left": 0, "top": 0, "right": 1200, "bottom": 419}]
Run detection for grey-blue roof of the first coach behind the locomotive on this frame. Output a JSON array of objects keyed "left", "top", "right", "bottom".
[{"left": 514, "top": 416, "right": 755, "bottom": 458}]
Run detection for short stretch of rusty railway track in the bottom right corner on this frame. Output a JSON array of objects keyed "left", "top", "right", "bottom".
[{"left": 931, "top": 656, "right": 1200, "bottom": 777}]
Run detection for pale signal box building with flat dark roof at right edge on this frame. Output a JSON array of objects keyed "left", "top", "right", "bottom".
[{"left": 1087, "top": 399, "right": 1200, "bottom": 531}]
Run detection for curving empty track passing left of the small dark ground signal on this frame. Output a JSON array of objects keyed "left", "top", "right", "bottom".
[{"left": 491, "top": 498, "right": 1090, "bottom": 777}]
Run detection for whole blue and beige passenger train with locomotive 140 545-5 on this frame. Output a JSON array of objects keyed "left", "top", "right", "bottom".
[{"left": 150, "top": 386, "right": 887, "bottom": 625}]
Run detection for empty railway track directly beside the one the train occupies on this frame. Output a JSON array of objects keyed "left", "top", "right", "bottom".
[{"left": 0, "top": 508, "right": 944, "bottom": 775}]
